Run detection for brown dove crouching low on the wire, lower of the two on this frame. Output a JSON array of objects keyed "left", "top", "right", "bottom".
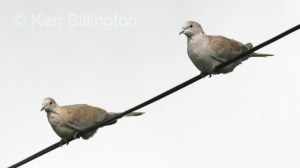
[{"left": 41, "top": 97, "right": 143, "bottom": 141}]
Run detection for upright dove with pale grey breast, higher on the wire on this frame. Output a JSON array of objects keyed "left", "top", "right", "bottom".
[{"left": 179, "top": 21, "right": 273, "bottom": 75}]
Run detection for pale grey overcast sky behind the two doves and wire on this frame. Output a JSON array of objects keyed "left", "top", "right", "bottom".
[{"left": 0, "top": 0, "right": 300, "bottom": 168}]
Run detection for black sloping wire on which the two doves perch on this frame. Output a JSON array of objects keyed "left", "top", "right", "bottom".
[{"left": 9, "top": 24, "right": 300, "bottom": 168}]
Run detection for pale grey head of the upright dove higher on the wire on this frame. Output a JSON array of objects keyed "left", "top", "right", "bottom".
[{"left": 179, "top": 21, "right": 204, "bottom": 37}]
